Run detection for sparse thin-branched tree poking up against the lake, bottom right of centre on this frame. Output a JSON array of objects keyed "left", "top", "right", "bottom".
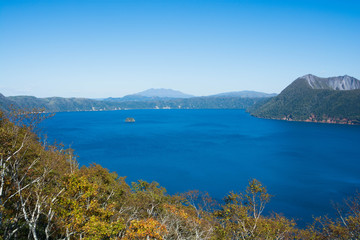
[{"left": 215, "top": 179, "right": 294, "bottom": 239}]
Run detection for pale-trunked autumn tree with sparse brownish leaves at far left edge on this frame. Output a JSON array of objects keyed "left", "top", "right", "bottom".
[{"left": 0, "top": 111, "right": 73, "bottom": 239}]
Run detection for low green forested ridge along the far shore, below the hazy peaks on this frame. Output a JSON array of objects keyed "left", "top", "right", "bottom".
[{"left": 0, "top": 94, "right": 263, "bottom": 112}]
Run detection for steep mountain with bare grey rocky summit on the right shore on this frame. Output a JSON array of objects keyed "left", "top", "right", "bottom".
[{"left": 250, "top": 74, "right": 360, "bottom": 124}]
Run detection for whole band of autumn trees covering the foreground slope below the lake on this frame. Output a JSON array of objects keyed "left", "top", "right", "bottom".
[{"left": 0, "top": 111, "right": 360, "bottom": 239}]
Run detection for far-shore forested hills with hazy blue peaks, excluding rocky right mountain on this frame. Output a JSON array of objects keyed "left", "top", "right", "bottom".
[{"left": 0, "top": 88, "right": 276, "bottom": 112}]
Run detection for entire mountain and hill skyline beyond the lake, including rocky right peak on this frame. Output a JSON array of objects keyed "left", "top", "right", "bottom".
[{"left": 0, "top": 74, "right": 360, "bottom": 124}]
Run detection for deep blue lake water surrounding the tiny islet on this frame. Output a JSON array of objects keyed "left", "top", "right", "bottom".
[{"left": 43, "top": 110, "right": 360, "bottom": 224}]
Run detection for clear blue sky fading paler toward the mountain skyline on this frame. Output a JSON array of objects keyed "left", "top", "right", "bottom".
[{"left": 0, "top": 0, "right": 360, "bottom": 97}]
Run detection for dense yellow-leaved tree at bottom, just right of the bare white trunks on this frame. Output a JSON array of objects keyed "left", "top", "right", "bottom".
[{"left": 56, "top": 172, "right": 125, "bottom": 239}]
